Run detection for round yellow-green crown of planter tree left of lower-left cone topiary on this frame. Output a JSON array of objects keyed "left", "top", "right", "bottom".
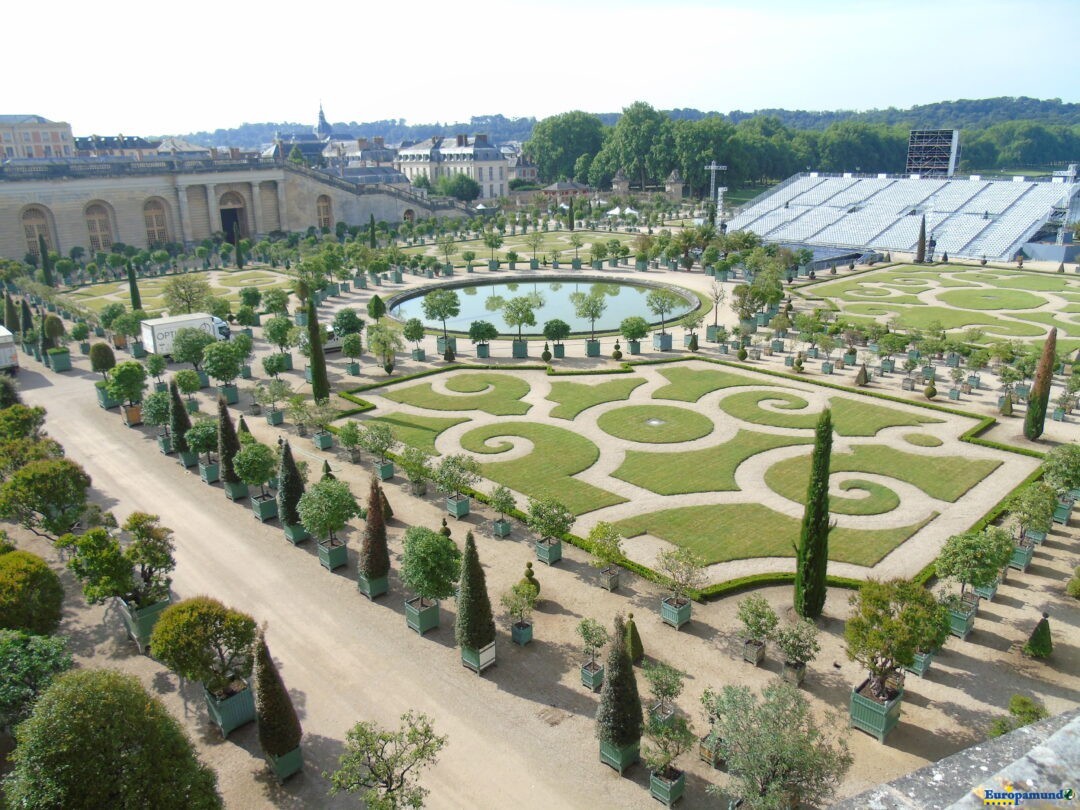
[{"left": 150, "top": 596, "right": 256, "bottom": 698}]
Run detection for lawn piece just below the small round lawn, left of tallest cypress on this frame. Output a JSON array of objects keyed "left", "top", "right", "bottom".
[{"left": 612, "top": 430, "right": 813, "bottom": 495}]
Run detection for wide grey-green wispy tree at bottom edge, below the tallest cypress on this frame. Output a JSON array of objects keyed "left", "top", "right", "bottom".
[{"left": 714, "top": 681, "right": 852, "bottom": 810}]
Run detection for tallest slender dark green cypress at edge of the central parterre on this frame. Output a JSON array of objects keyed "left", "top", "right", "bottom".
[{"left": 795, "top": 408, "right": 833, "bottom": 619}]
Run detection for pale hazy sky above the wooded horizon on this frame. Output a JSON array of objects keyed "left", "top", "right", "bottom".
[{"left": 10, "top": 0, "right": 1080, "bottom": 135}]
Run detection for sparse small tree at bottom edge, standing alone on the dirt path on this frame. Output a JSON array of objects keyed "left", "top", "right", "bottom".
[{"left": 326, "top": 712, "right": 446, "bottom": 810}]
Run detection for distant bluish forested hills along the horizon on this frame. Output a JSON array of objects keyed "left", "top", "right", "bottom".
[{"left": 172, "top": 96, "right": 1080, "bottom": 148}]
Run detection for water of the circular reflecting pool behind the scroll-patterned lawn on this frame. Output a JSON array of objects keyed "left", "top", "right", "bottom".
[{"left": 390, "top": 279, "right": 698, "bottom": 335}]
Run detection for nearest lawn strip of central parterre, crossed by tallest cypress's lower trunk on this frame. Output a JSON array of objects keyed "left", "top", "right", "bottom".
[{"left": 616, "top": 503, "right": 937, "bottom": 566}]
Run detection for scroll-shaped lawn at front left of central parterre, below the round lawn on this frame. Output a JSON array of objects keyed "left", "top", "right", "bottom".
[{"left": 461, "top": 421, "right": 625, "bottom": 515}]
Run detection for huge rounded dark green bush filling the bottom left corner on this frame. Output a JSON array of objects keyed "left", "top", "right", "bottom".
[{"left": 5, "top": 670, "right": 225, "bottom": 810}]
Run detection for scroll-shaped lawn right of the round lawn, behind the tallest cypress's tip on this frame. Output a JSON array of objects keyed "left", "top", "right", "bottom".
[{"left": 719, "top": 389, "right": 941, "bottom": 436}]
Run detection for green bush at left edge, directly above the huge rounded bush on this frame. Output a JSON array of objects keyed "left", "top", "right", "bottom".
[{"left": 0, "top": 630, "right": 71, "bottom": 730}]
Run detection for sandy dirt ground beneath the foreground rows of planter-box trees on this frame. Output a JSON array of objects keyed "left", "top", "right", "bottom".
[{"left": 12, "top": 264, "right": 1080, "bottom": 808}]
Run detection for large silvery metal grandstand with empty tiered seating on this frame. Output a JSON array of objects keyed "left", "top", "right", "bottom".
[{"left": 727, "top": 172, "right": 1080, "bottom": 260}]
